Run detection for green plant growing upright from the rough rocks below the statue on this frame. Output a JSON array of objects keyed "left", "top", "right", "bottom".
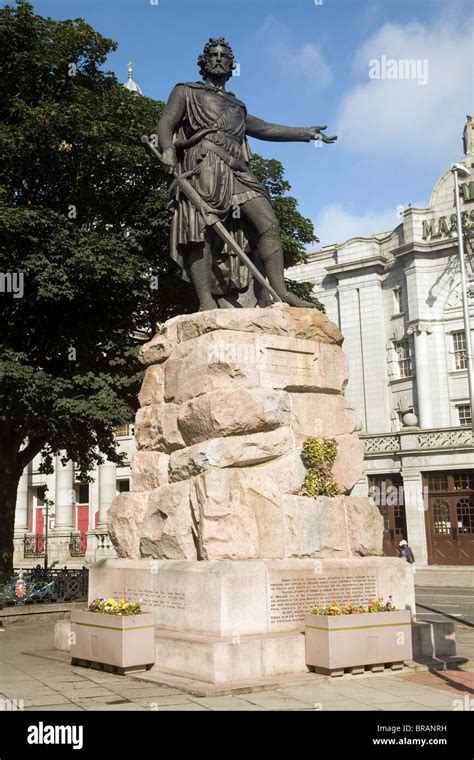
[{"left": 300, "top": 438, "right": 339, "bottom": 497}]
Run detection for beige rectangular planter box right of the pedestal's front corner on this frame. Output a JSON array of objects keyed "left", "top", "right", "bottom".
[{"left": 305, "top": 610, "right": 413, "bottom": 673}]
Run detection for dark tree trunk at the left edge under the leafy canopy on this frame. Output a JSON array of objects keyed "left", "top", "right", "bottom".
[{"left": 0, "top": 447, "right": 23, "bottom": 582}]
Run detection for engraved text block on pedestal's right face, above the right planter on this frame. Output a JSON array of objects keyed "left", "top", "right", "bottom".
[{"left": 269, "top": 575, "right": 377, "bottom": 625}]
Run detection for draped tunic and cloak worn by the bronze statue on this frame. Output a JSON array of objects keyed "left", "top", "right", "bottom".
[{"left": 170, "top": 82, "right": 269, "bottom": 292}]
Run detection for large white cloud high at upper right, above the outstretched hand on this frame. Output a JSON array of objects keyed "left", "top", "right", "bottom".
[{"left": 337, "top": 15, "right": 473, "bottom": 163}]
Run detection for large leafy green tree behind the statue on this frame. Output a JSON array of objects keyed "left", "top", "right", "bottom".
[{"left": 0, "top": 0, "right": 322, "bottom": 577}]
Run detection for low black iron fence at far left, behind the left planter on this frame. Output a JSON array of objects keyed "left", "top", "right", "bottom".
[{"left": 0, "top": 565, "right": 89, "bottom": 607}]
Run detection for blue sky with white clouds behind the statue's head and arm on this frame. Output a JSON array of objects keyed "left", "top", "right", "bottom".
[{"left": 15, "top": 0, "right": 474, "bottom": 244}]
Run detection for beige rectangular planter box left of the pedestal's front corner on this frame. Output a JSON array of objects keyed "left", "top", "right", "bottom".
[{"left": 71, "top": 610, "right": 155, "bottom": 674}]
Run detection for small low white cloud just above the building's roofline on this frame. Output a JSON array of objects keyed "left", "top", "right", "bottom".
[{"left": 315, "top": 203, "right": 402, "bottom": 246}]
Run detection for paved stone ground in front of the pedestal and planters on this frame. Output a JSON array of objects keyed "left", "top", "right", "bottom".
[{"left": 0, "top": 620, "right": 474, "bottom": 712}]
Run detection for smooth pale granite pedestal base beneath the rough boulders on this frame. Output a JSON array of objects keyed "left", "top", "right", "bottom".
[{"left": 89, "top": 557, "right": 415, "bottom": 684}]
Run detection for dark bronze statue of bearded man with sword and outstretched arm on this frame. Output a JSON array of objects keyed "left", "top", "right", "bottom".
[{"left": 157, "top": 37, "right": 337, "bottom": 311}]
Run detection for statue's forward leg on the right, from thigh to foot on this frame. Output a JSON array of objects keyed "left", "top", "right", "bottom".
[{"left": 241, "top": 196, "right": 314, "bottom": 309}]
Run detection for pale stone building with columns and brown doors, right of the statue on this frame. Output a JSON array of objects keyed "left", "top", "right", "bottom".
[{"left": 288, "top": 117, "right": 474, "bottom": 565}]
